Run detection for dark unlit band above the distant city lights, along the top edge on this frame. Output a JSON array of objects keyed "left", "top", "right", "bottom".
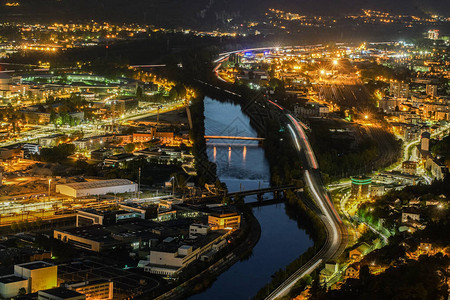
[{"left": 0, "top": 0, "right": 450, "bottom": 26}]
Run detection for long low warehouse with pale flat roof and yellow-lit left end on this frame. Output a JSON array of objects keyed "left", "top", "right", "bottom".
[{"left": 56, "top": 179, "right": 137, "bottom": 198}]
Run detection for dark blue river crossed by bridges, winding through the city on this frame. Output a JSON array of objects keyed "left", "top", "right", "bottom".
[{"left": 189, "top": 98, "right": 313, "bottom": 300}]
